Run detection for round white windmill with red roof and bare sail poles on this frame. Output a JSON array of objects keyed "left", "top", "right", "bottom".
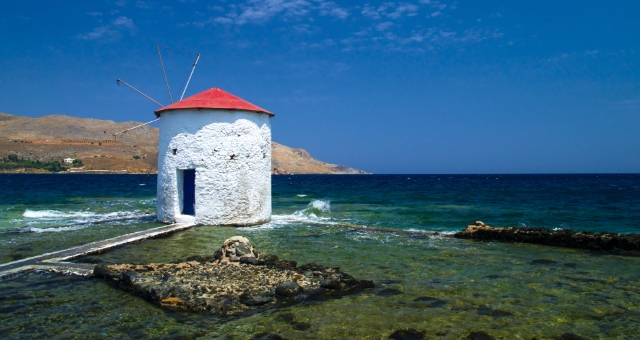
[{"left": 114, "top": 45, "right": 274, "bottom": 226}]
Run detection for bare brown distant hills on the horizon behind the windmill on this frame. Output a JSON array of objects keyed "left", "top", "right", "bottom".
[{"left": 0, "top": 113, "right": 366, "bottom": 174}]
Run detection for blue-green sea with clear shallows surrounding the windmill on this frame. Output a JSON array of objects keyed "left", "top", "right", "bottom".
[{"left": 0, "top": 174, "right": 640, "bottom": 339}]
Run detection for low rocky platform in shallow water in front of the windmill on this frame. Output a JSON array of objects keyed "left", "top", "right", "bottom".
[{"left": 94, "top": 236, "right": 374, "bottom": 316}]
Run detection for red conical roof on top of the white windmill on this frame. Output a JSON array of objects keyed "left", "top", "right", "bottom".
[{"left": 154, "top": 87, "right": 273, "bottom": 117}]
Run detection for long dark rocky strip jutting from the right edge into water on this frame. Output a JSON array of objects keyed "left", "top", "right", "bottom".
[{"left": 454, "top": 221, "right": 640, "bottom": 251}]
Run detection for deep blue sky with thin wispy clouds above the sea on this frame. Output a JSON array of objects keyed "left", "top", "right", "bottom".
[{"left": 0, "top": 0, "right": 640, "bottom": 174}]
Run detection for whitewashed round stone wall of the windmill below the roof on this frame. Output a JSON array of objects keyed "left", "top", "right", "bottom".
[{"left": 158, "top": 109, "right": 271, "bottom": 225}]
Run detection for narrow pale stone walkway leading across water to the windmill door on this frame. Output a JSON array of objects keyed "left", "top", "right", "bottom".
[{"left": 0, "top": 223, "right": 195, "bottom": 280}]
